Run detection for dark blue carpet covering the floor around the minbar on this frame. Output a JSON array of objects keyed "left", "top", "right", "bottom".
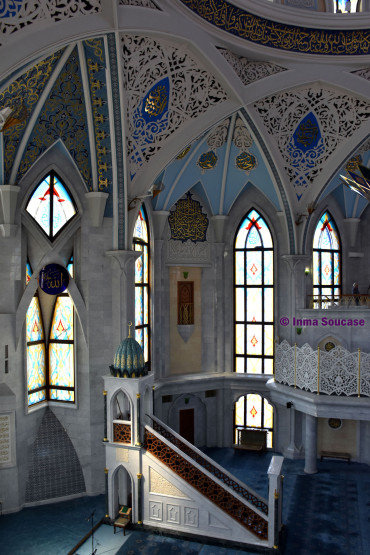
[{"left": 0, "top": 449, "right": 370, "bottom": 555}]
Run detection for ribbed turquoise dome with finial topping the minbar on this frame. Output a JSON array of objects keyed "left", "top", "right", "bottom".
[{"left": 109, "top": 322, "right": 148, "bottom": 378}]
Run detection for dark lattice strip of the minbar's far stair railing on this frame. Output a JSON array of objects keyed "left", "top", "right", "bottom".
[{"left": 153, "top": 421, "right": 268, "bottom": 515}]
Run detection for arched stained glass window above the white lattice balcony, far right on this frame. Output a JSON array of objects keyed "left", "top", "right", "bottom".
[{"left": 313, "top": 212, "right": 341, "bottom": 308}]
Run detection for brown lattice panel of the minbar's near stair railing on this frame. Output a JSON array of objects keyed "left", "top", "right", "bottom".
[{"left": 145, "top": 430, "right": 268, "bottom": 540}]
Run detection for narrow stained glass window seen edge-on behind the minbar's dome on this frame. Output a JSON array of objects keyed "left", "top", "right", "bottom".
[{"left": 133, "top": 206, "right": 150, "bottom": 367}]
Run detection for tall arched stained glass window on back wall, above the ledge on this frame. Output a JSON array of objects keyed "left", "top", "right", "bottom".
[{"left": 234, "top": 209, "right": 274, "bottom": 374}]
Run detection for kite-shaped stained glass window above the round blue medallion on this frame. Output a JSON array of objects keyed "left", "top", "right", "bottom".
[{"left": 26, "top": 172, "right": 77, "bottom": 241}]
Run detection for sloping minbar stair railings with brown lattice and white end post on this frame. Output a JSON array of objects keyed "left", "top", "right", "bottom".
[{"left": 144, "top": 416, "right": 283, "bottom": 547}]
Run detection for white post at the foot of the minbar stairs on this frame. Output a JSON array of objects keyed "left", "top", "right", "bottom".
[{"left": 267, "top": 456, "right": 284, "bottom": 549}]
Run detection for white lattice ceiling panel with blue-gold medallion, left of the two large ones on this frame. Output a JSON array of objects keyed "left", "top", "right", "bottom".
[{"left": 121, "top": 35, "right": 227, "bottom": 179}]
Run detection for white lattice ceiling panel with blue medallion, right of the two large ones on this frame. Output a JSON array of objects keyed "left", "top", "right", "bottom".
[{"left": 254, "top": 85, "right": 370, "bottom": 201}]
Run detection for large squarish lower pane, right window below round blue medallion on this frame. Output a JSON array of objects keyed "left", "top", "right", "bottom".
[{"left": 49, "top": 343, "right": 74, "bottom": 387}]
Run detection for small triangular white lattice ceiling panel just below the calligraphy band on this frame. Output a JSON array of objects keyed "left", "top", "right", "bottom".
[{"left": 218, "top": 48, "right": 286, "bottom": 85}]
